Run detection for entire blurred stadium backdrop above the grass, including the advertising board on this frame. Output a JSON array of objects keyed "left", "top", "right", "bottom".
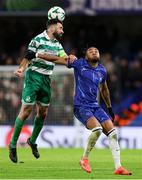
[{"left": 0, "top": 0, "right": 142, "bottom": 148}]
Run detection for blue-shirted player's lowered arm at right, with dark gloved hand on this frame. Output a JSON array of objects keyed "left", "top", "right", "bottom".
[{"left": 99, "top": 81, "right": 115, "bottom": 122}]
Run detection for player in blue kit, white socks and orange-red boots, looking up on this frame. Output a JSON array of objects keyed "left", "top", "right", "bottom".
[{"left": 36, "top": 47, "right": 131, "bottom": 175}]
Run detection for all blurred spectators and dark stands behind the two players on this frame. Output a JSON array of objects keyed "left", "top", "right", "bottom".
[{"left": 0, "top": 18, "right": 142, "bottom": 125}]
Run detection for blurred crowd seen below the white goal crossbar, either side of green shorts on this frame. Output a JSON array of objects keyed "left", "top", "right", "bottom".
[{"left": 0, "top": 70, "right": 74, "bottom": 125}]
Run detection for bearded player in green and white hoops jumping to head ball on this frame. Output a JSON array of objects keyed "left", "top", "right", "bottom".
[{"left": 9, "top": 19, "right": 67, "bottom": 163}]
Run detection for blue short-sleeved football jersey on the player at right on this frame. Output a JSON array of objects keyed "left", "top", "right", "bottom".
[{"left": 68, "top": 58, "right": 107, "bottom": 107}]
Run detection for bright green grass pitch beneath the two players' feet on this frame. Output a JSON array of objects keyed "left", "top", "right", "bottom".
[{"left": 0, "top": 148, "right": 142, "bottom": 179}]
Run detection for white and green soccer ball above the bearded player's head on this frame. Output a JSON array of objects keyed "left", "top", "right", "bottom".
[{"left": 48, "top": 6, "right": 65, "bottom": 21}]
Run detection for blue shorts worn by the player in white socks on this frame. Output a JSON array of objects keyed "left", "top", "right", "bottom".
[{"left": 74, "top": 106, "right": 110, "bottom": 125}]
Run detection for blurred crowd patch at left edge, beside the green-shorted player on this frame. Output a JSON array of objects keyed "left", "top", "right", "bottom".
[{"left": 0, "top": 70, "right": 22, "bottom": 124}]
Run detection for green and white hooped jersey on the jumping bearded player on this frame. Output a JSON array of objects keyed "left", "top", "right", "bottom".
[{"left": 28, "top": 30, "right": 66, "bottom": 75}]
